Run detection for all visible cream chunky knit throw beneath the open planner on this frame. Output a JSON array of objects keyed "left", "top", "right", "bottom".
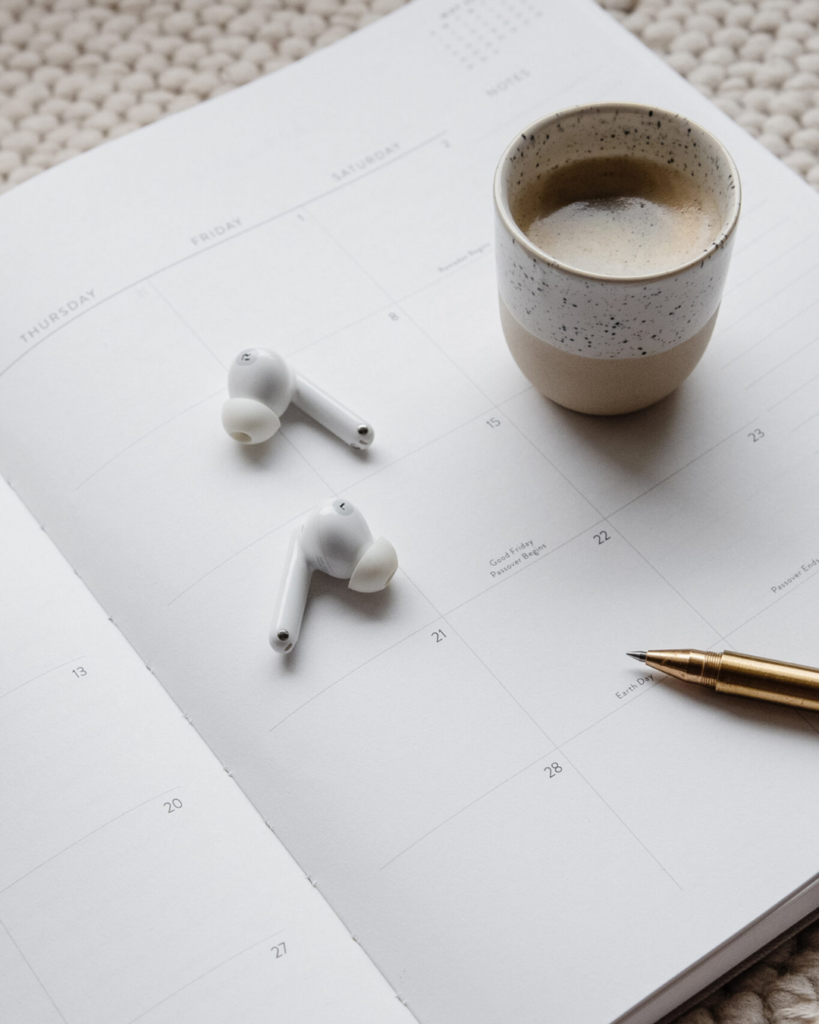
[{"left": 0, "top": 0, "right": 819, "bottom": 1024}]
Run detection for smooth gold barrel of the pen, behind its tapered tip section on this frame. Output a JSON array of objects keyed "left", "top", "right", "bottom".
[{"left": 716, "top": 651, "right": 819, "bottom": 711}]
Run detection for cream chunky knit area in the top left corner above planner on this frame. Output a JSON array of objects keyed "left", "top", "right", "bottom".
[{"left": 0, "top": 0, "right": 403, "bottom": 190}]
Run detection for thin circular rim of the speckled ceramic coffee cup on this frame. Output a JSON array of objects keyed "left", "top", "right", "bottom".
[{"left": 492, "top": 101, "right": 742, "bottom": 285}]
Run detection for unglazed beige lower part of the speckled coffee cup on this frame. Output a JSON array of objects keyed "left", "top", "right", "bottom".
[{"left": 500, "top": 299, "right": 719, "bottom": 416}]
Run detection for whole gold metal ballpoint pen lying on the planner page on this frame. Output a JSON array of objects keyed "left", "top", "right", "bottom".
[{"left": 628, "top": 650, "right": 819, "bottom": 711}]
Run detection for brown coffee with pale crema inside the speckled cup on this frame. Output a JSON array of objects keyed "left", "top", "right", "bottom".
[{"left": 512, "top": 157, "right": 723, "bottom": 278}]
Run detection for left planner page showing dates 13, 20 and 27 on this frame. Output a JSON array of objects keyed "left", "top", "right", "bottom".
[{"left": 0, "top": 483, "right": 412, "bottom": 1024}]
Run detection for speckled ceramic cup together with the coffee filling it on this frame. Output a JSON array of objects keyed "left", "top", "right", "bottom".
[{"left": 494, "top": 103, "right": 740, "bottom": 415}]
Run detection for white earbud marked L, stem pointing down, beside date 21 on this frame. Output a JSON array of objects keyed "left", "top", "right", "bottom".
[{"left": 270, "top": 498, "right": 398, "bottom": 654}]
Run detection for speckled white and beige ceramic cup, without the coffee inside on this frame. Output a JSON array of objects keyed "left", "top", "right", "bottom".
[{"left": 494, "top": 103, "right": 740, "bottom": 416}]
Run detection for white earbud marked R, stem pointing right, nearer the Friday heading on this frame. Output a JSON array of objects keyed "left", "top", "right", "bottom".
[{"left": 222, "top": 348, "right": 374, "bottom": 449}]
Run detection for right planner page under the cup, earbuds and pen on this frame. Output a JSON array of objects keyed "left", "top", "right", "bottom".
[{"left": 0, "top": 0, "right": 819, "bottom": 1024}]
